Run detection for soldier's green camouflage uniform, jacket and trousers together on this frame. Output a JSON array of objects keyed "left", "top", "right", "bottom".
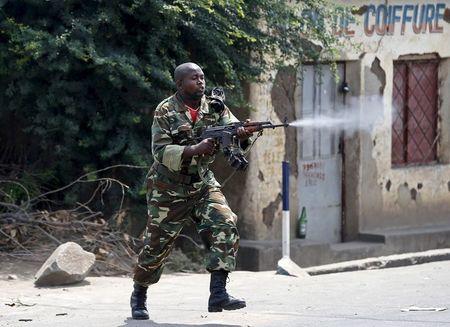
[{"left": 134, "top": 94, "right": 246, "bottom": 286}]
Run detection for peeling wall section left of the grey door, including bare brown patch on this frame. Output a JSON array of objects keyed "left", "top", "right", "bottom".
[{"left": 235, "top": 74, "right": 296, "bottom": 240}]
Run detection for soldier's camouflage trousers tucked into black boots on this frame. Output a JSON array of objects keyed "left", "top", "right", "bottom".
[{"left": 134, "top": 173, "right": 239, "bottom": 286}]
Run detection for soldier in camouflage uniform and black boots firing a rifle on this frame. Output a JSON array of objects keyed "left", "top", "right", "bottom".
[{"left": 130, "top": 63, "right": 251, "bottom": 319}]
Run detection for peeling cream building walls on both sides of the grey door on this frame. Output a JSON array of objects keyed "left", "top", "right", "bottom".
[{"left": 231, "top": 0, "right": 450, "bottom": 240}]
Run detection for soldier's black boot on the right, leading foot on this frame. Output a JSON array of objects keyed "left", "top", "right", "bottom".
[{"left": 208, "top": 270, "right": 246, "bottom": 312}]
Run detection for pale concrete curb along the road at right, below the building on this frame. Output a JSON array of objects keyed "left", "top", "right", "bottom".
[{"left": 305, "top": 248, "right": 450, "bottom": 276}]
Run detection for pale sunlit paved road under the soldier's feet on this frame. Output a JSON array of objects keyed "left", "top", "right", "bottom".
[{"left": 0, "top": 261, "right": 450, "bottom": 327}]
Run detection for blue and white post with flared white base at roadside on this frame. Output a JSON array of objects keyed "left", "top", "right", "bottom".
[{"left": 277, "top": 161, "right": 309, "bottom": 277}]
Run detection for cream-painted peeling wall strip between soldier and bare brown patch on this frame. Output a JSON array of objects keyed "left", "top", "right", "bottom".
[{"left": 237, "top": 75, "right": 286, "bottom": 240}]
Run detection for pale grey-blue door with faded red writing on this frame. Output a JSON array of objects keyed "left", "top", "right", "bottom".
[{"left": 296, "top": 63, "right": 345, "bottom": 243}]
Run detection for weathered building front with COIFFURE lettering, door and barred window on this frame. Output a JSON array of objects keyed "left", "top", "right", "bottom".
[{"left": 225, "top": 0, "right": 450, "bottom": 270}]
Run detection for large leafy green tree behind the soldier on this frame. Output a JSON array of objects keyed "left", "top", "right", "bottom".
[{"left": 0, "top": 0, "right": 348, "bottom": 220}]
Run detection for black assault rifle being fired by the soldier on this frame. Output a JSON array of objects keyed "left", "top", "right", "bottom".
[{"left": 197, "top": 121, "right": 289, "bottom": 170}]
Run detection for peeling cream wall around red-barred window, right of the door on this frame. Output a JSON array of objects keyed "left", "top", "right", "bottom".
[{"left": 343, "top": 1, "right": 450, "bottom": 236}]
